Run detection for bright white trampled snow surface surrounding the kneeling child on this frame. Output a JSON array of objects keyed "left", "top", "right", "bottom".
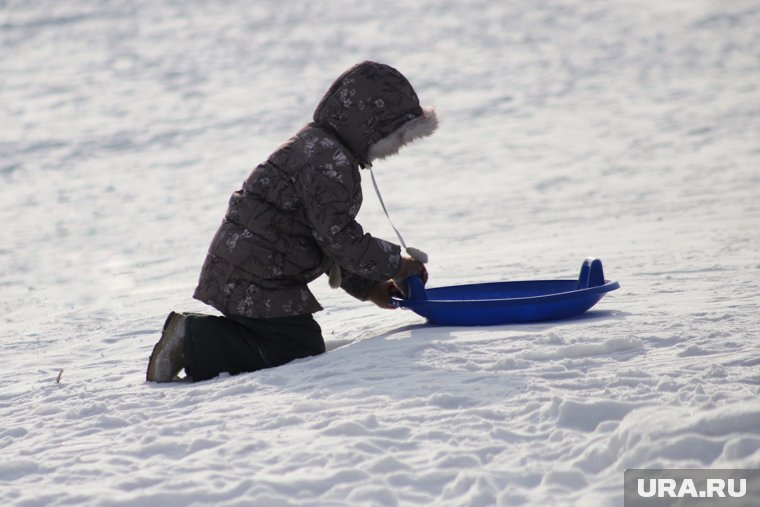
[{"left": 0, "top": 0, "right": 760, "bottom": 507}]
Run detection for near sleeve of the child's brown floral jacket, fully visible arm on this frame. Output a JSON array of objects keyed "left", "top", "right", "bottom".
[{"left": 298, "top": 145, "right": 401, "bottom": 286}]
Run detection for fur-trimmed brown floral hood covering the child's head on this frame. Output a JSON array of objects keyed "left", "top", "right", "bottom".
[{"left": 314, "top": 61, "right": 438, "bottom": 167}]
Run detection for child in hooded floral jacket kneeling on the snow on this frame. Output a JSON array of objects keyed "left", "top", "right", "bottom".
[{"left": 147, "top": 62, "right": 438, "bottom": 382}]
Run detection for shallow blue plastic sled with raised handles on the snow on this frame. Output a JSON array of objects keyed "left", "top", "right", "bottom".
[{"left": 391, "top": 258, "right": 620, "bottom": 326}]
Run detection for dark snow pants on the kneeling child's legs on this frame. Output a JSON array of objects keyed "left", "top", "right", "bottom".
[{"left": 185, "top": 313, "right": 325, "bottom": 381}]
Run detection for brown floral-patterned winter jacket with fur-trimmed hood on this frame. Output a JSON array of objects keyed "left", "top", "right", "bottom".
[{"left": 193, "top": 62, "right": 438, "bottom": 318}]
